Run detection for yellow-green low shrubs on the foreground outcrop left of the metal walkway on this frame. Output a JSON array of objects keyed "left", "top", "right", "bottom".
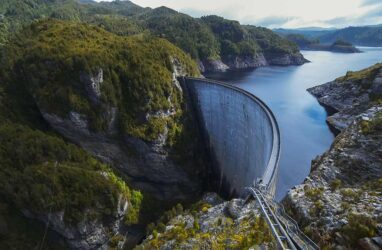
[{"left": 136, "top": 199, "right": 273, "bottom": 249}]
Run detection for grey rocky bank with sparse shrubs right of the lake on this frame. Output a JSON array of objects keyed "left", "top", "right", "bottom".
[{"left": 284, "top": 64, "right": 382, "bottom": 249}]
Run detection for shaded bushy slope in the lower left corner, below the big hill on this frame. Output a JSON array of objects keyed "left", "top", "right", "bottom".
[{"left": 0, "top": 33, "right": 142, "bottom": 249}]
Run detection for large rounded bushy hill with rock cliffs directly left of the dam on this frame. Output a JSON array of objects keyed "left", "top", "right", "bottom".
[{"left": 5, "top": 21, "right": 201, "bottom": 199}]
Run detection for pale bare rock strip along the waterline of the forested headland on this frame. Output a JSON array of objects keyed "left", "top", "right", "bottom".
[{"left": 199, "top": 53, "right": 308, "bottom": 72}]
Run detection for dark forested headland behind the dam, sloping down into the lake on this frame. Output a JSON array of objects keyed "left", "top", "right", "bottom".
[{"left": 133, "top": 11, "right": 306, "bottom": 71}]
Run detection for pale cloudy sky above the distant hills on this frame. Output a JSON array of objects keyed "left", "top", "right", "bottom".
[{"left": 97, "top": 0, "right": 382, "bottom": 28}]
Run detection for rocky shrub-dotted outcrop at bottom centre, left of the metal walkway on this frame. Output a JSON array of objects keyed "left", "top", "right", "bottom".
[{"left": 137, "top": 193, "right": 276, "bottom": 249}]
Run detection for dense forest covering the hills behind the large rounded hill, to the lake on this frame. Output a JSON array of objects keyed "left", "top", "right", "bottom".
[{"left": 0, "top": 0, "right": 304, "bottom": 69}]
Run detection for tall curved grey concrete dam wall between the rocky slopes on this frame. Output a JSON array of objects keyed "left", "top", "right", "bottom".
[{"left": 181, "top": 78, "right": 280, "bottom": 197}]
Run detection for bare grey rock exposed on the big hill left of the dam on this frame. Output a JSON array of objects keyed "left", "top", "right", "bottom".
[{"left": 41, "top": 59, "right": 201, "bottom": 200}]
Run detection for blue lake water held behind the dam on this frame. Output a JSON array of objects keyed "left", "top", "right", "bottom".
[{"left": 207, "top": 47, "right": 382, "bottom": 199}]
